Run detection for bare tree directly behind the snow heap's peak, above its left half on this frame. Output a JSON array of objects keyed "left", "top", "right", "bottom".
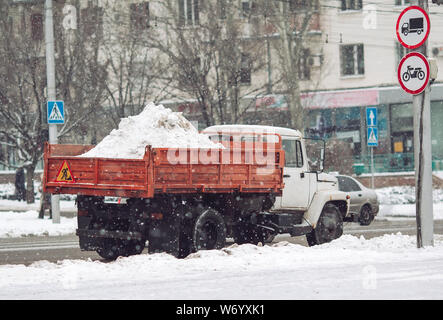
[{"left": 103, "top": 2, "right": 168, "bottom": 126}]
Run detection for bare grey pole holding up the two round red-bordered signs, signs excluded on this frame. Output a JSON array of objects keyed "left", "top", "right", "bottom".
[{"left": 412, "top": 0, "right": 434, "bottom": 248}]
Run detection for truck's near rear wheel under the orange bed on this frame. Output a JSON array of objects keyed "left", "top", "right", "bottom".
[{"left": 192, "top": 209, "right": 226, "bottom": 251}]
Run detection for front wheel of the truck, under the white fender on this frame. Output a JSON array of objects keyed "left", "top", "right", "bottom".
[{"left": 306, "top": 203, "right": 343, "bottom": 247}]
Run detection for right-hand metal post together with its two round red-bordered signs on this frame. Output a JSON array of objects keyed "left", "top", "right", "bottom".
[{"left": 396, "top": 0, "right": 434, "bottom": 248}]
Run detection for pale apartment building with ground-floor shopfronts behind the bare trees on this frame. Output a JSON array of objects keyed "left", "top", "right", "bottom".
[{"left": 3, "top": 0, "right": 443, "bottom": 175}]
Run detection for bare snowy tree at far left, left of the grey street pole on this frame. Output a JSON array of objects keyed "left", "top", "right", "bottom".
[{"left": 0, "top": 2, "right": 47, "bottom": 203}]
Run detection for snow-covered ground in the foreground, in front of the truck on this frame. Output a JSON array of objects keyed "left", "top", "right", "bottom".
[{"left": 0, "top": 234, "right": 443, "bottom": 300}]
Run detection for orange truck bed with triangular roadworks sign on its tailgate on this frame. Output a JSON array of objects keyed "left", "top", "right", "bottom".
[{"left": 43, "top": 136, "right": 284, "bottom": 198}]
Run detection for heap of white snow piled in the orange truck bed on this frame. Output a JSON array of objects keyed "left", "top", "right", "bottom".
[{"left": 80, "top": 103, "right": 222, "bottom": 159}]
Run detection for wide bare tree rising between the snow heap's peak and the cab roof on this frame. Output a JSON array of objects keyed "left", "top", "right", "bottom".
[{"left": 149, "top": 0, "right": 264, "bottom": 126}]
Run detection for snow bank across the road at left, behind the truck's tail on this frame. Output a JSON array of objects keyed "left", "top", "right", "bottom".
[{"left": 0, "top": 210, "right": 77, "bottom": 238}]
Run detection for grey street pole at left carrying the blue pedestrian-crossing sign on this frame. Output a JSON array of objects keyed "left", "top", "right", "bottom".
[{"left": 45, "top": 0, "right": 60, "bottom": 223}]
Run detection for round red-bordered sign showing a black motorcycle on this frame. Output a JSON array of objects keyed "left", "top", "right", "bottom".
[{"left": 397, "top": 52, "right": 429, "bottom": 94}]
